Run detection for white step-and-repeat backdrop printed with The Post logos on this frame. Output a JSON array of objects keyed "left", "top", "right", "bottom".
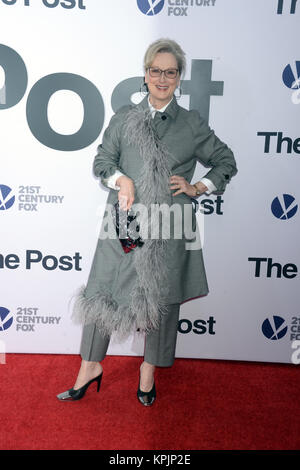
[{"left": 0, "top": 0, "right": 300, "bottom": 364}]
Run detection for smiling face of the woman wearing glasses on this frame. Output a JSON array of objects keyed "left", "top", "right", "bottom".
[{"left": 145, "top": 52, "right": 180, "bottom": 109}]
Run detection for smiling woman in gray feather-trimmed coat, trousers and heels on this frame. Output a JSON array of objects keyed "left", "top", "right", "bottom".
[{"left": 58, "top": 39, "right": 237, "bottom": 406}]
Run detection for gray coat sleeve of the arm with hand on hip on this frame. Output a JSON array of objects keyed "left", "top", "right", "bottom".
[{"left": 190, "top": 111, "right": 237, "bottom": 192}]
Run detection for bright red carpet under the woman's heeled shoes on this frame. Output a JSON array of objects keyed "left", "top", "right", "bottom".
[{"left": 0, "top": 354, "right": 300, "bottom": 450}]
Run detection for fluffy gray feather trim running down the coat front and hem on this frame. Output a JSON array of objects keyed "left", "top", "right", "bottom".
[{"left": 72, "top": 106, "right": 171, "bottom": 338}]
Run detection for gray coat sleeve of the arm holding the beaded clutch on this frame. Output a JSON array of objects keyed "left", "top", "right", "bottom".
[{"left": 93, "top": 106, "right": 128, "bottom": 186}]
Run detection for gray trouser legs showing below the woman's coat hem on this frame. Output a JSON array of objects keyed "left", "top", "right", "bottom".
[{"left": 80, "top": 304, "right": 180, "bottom": 367}]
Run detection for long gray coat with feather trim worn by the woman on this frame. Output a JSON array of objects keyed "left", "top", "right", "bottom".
[{"left": 74, "top": 97, "right": 237, "bottom": 335}]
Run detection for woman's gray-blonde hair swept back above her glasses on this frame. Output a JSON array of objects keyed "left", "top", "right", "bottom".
[{"left": 144, "top": 39, "right": 186, "bottom": 75}]
